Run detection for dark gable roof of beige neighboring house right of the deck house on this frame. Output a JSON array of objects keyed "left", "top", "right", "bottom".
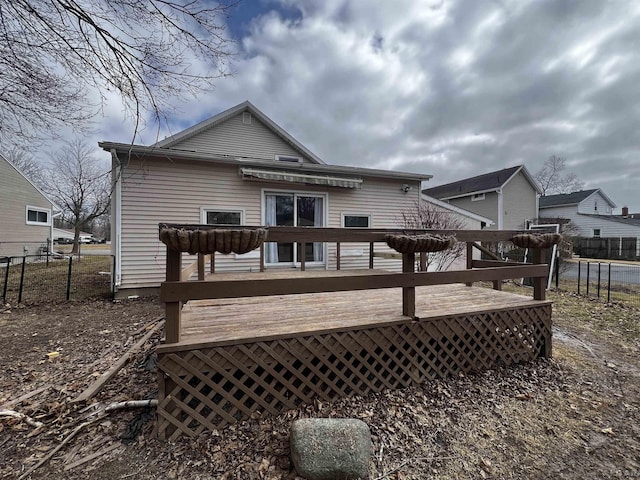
[{"left": 422, "top": 165, "right": 541, "bottom": 200}]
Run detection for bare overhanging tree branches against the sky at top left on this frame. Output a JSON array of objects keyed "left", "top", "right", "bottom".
[{"left": 0, "top": 0, "right": 233, "bottom": 139}]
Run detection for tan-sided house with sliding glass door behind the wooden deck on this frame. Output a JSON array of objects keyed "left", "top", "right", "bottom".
[{"left": 99, "top": 102, "right": 440, "bottom": 295}]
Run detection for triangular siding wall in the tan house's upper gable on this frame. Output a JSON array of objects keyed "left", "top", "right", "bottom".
[{"left": 166, "top": 113, "right": 315, "bottom": 163}]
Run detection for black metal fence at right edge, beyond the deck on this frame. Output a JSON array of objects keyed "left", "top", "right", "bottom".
[{"left": 555, "top": 261, "right": 640, "bottom": 306}]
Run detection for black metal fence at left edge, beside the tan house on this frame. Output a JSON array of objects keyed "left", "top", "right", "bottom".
[{"left": 0, "top": 255, "right": 114, "bottom": 303}]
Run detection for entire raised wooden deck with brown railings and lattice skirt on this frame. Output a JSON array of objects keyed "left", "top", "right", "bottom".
[{"left": 156, "top": 224, "right": 551, "bottom": 439}]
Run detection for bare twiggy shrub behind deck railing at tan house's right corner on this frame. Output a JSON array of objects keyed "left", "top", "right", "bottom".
[{"left": 399, "top": 200, "right": 465, "bottom": 271}]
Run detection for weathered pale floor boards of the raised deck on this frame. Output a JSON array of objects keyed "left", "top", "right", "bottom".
[{"left": 160, "top": 282, "right": 549, "bottom": 350}]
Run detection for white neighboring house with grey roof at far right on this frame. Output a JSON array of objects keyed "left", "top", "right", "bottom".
[{"left": 540, "top": 188, "right": 640, "bottom": 257}]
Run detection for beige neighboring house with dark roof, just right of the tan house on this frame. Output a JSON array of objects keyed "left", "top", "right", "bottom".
[{"left": 423, "top": 165, "right": 542, "bottom": 230}]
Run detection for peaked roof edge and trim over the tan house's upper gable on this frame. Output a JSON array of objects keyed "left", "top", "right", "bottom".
[{"left": 152, "top": 100, "right": 325, "bottom": 165}]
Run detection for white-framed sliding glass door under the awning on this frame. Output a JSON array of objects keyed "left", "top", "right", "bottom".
[{"left": 264, "top": 192, "right": 325, "bottom": 265}]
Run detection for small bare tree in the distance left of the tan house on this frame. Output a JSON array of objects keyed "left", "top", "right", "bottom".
[{"left": 45, "top": 140, "right": 111, "bottom": 253}]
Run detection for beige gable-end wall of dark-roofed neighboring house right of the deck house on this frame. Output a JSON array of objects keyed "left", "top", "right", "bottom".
[{"left": 502, "top": 171, "right": 538, "bottom": 230}]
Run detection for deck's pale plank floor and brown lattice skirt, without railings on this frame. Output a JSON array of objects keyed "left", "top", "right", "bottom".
[{"left": 156, "top": 271, "right": 551, "bottom": 439}]
